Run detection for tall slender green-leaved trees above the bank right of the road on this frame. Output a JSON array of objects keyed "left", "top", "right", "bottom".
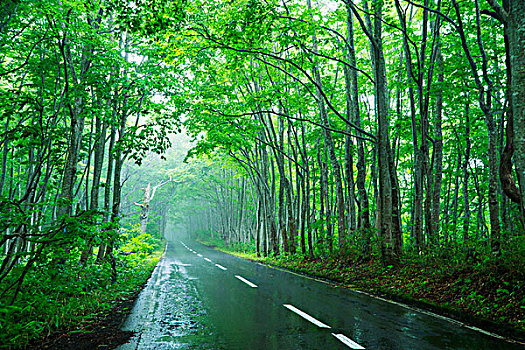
[{"left": 174, "top": 0, "right": 522, "bottom": 262}]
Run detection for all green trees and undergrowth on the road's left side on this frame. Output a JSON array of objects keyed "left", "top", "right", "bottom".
[{"left": 0, "top": 0, "right": 178, "bottom": 349}]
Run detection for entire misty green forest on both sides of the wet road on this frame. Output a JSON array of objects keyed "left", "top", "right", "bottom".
[{"left": 0, "top": 0, "right": 525, "bottom": 347}]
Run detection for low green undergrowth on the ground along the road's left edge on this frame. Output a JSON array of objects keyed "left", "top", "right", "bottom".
[{"left": 0, "top": 242, "right": 164, "bottom": 349}]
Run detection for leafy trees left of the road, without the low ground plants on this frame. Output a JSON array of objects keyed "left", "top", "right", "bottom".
[{"left": 0, "top": 0, "right": 177, "bottom": 301}]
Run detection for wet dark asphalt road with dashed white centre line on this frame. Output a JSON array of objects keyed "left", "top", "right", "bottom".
[{"left": 119, "top": 241, "right": 523, "bottom": 350}]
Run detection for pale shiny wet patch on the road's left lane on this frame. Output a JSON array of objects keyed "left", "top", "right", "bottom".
[{"left": 117, "top": 257, "right": 225, "bottom": 350}]
